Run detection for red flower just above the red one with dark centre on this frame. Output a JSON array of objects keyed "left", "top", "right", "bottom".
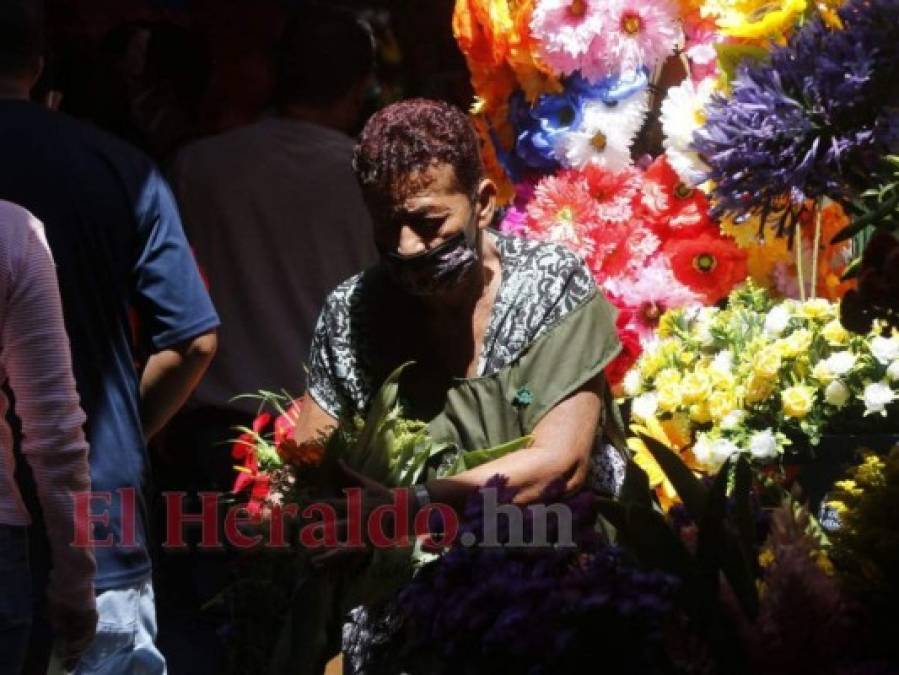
[{"left": 635, "top": 155, "right": 714, "bottom": 237}]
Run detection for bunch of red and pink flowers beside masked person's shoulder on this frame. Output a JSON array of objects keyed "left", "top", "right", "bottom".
[{"left": 500, "top": 156, "right": 747, "bottom": 383}]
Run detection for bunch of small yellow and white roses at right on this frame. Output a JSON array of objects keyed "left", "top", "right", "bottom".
[{"left": 623, "top": 283, "right": 899, "bottom": 472}]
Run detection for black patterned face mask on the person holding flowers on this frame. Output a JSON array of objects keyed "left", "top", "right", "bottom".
[{"left": 382, "top": 232, "right": 479, "bottom": 296}]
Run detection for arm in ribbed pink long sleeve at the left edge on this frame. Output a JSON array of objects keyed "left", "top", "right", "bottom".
[{"left": 2, "top": 216, "right": 97, "bottom": 660}]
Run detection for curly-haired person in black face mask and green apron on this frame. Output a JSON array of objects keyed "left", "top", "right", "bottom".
[{"left": 295, "top": 99, "right": 620, "bottom": 508}]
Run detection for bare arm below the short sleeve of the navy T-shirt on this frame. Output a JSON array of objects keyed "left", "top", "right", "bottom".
[{"left": 140, "top": 331, "right": 217, "bottom": 438}]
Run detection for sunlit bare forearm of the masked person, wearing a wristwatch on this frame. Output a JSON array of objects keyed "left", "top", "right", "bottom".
[{"left": 426, "top": 374, "right": 603, "bottom": 512}]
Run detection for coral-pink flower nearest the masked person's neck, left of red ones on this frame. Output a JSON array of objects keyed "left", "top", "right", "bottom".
[{"left": 527, "top": 172, "right": 599, "bottom": 259}]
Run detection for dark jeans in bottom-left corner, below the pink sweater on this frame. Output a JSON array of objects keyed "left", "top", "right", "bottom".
[{"left": 0, "top": 525, "right": 32, "bottom": 675}]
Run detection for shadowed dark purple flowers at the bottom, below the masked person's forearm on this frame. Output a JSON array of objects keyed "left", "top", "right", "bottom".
[{"left": 362, "top": 479, "right": 676, "bottom": 675}]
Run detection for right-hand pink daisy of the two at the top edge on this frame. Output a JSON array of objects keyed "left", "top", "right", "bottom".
[{"left": 581, "top": 0, "right": 680, "bottom": 81}]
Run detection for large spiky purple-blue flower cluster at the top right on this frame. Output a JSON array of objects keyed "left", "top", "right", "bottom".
[{"left": 694, "top": 0, "right": 899, "bottom": 238}]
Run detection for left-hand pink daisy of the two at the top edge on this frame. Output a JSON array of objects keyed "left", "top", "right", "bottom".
[{"left": 531, "top": 0, "right": 605, "bottom": 75}]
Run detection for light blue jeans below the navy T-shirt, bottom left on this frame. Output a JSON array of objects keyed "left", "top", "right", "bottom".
[{"left": 73, "top": 579, "right": 166, "bottom": 675}]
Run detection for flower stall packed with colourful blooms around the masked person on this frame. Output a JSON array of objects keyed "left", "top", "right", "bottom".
[{"left": 223, "top": 0, "right": 899, "bottom": 673}]
